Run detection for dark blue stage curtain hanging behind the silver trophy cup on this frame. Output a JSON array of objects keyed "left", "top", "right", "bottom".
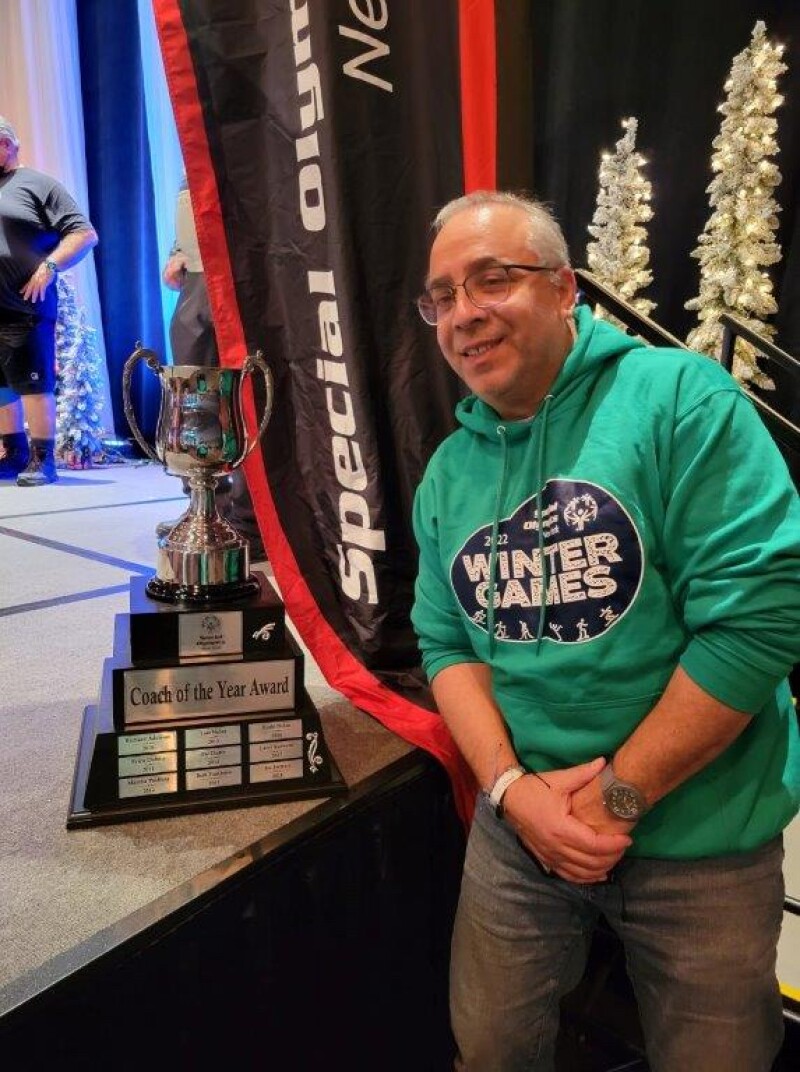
[{"left": 77, "top": 0, "right": 164, "bottom": 437}]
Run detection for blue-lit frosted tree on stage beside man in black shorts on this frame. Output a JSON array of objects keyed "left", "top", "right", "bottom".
[{"left": 56, "top": 276, "right": 103, "bottom": 465}]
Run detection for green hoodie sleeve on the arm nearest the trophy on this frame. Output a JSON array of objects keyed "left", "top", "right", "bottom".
[{"left": 411, "top": 467, "right": 480, "bottom": 681}]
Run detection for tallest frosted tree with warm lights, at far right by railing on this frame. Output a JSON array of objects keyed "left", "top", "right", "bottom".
[{"left": 686, "top": 21, "right": 786, "bottom": 387}]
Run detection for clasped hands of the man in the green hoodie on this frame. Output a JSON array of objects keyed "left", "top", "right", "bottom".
[{"left": 503, "top": 757, "right": 634, "bottom": 883}]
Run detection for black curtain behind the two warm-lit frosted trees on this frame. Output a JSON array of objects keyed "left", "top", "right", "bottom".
[{"left": 530, "top": 0, "right": 800, "bottom": 381}]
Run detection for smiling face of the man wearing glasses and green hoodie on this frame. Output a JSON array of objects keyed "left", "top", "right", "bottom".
[{"left": 427, "top": 205, "right": 575, "bottom": 420}]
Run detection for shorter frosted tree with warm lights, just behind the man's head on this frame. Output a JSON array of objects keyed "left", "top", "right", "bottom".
[{"left": 587, "top": 117, "right": 655, "bottom": 319}]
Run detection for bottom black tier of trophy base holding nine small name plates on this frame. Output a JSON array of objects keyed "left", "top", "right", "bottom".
[{"left": 66, "top": 693, "right": 347, "bottom": 830}]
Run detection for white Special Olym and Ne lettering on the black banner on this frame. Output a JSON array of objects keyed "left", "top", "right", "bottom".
[{"left": 290, "top": 12, "right": 383, "bottom": 604}]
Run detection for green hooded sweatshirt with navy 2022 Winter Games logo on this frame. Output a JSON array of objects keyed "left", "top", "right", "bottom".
[{"left": 413, "top": 307, "right": 800, "bottom": 859}]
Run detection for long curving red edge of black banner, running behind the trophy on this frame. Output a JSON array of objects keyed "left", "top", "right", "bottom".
[{"left": 153, "top": 0, "right": 475, "bottom": 821}]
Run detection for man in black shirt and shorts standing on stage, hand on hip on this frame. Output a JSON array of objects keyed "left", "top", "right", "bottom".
[{"left": 0, "top": 116, "right": 98, "bottom": 487}]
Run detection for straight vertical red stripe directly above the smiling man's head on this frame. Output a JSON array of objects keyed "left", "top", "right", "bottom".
[{"left": 458, "top": 0, "right": 498, "bottom": 193}]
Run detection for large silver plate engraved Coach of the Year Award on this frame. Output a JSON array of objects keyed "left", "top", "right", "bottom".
[{"left": 124, "top": 659, "right": 296, "bottom": 726}]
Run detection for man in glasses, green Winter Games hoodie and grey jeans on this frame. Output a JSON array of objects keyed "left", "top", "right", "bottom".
[{"left": 413, "top": 193, "right": 800, "bottom": 1072}]
